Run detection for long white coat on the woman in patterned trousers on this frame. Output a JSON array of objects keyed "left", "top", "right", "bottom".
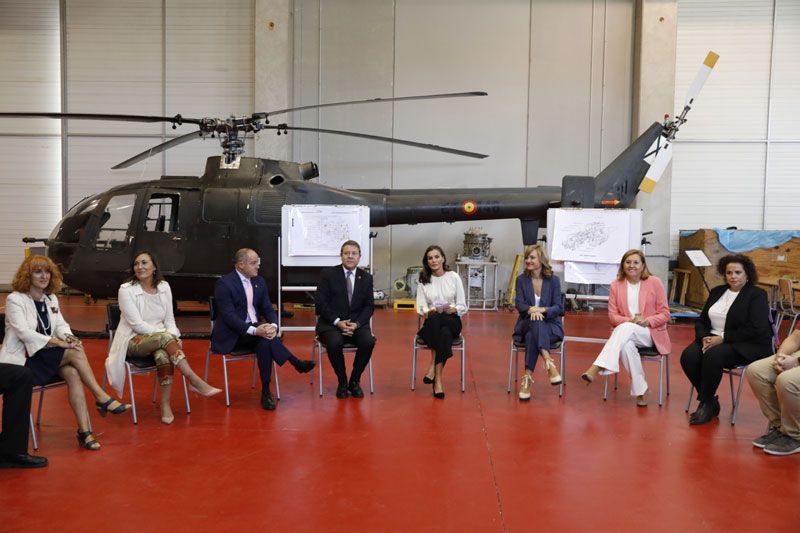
[{"left": 106, "top": 281, "right": 181, "bottom": 395}]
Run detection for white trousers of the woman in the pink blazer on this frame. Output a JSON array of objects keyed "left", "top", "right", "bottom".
[{"left": 594, "top": 322, "right": 653, "bottom": 396}]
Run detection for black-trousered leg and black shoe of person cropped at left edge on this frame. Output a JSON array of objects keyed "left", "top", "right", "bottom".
[{"left": 0, "top": 363, "right": 47, "bottom": 468}]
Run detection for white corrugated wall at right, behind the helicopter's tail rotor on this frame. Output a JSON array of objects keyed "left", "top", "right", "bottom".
[{"left": 671, "top": 0, "right": 800, "bottom": 249}]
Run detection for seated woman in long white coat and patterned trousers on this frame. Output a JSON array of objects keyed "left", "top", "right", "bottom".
[{"left": 106, "top": 251, "right": 222, "bottom": 424}]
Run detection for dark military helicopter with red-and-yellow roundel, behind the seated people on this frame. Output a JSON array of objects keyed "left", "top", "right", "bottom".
[{"left": 0, "top": 52, "right": 718, "bottom": 301}]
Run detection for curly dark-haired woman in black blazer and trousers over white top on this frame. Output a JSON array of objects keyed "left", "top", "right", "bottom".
[{"left": 681, "top": 255, "right": 773, "bottom": 426}]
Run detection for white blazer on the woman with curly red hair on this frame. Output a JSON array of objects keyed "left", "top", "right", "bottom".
[{"left": 0, "top": 292, "right": 72, "bottom": 365}]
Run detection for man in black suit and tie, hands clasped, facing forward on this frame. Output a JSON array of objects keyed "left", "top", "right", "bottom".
[{"left": 316, "top": 241, "right": 375, "bottom": 398}]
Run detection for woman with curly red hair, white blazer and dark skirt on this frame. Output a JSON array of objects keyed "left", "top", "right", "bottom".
[{"left": 0, "top": 255, "right": 130, "bottom": 450}]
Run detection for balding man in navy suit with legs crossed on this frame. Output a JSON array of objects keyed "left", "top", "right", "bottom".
[{"left": 211, "top": 248, "right": 315, "bottom": 411}]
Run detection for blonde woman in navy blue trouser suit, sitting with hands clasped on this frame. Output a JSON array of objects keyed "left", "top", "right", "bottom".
[{"left": 514, "top": 244, "right": 564, "bottom": 400}]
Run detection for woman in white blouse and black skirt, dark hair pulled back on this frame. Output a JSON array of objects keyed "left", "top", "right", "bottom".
[{"left": 417, "top": 244, "right": 467, "bottom": 399}]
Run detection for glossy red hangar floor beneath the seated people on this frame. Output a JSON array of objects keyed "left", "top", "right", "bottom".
[{"left": 0, "top": 297, "right": 800, "bottom": 532}]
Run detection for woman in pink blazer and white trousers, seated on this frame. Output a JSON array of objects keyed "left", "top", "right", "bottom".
[{"left": 581, "top": 250, "right": 671, "bottom": 407}]
